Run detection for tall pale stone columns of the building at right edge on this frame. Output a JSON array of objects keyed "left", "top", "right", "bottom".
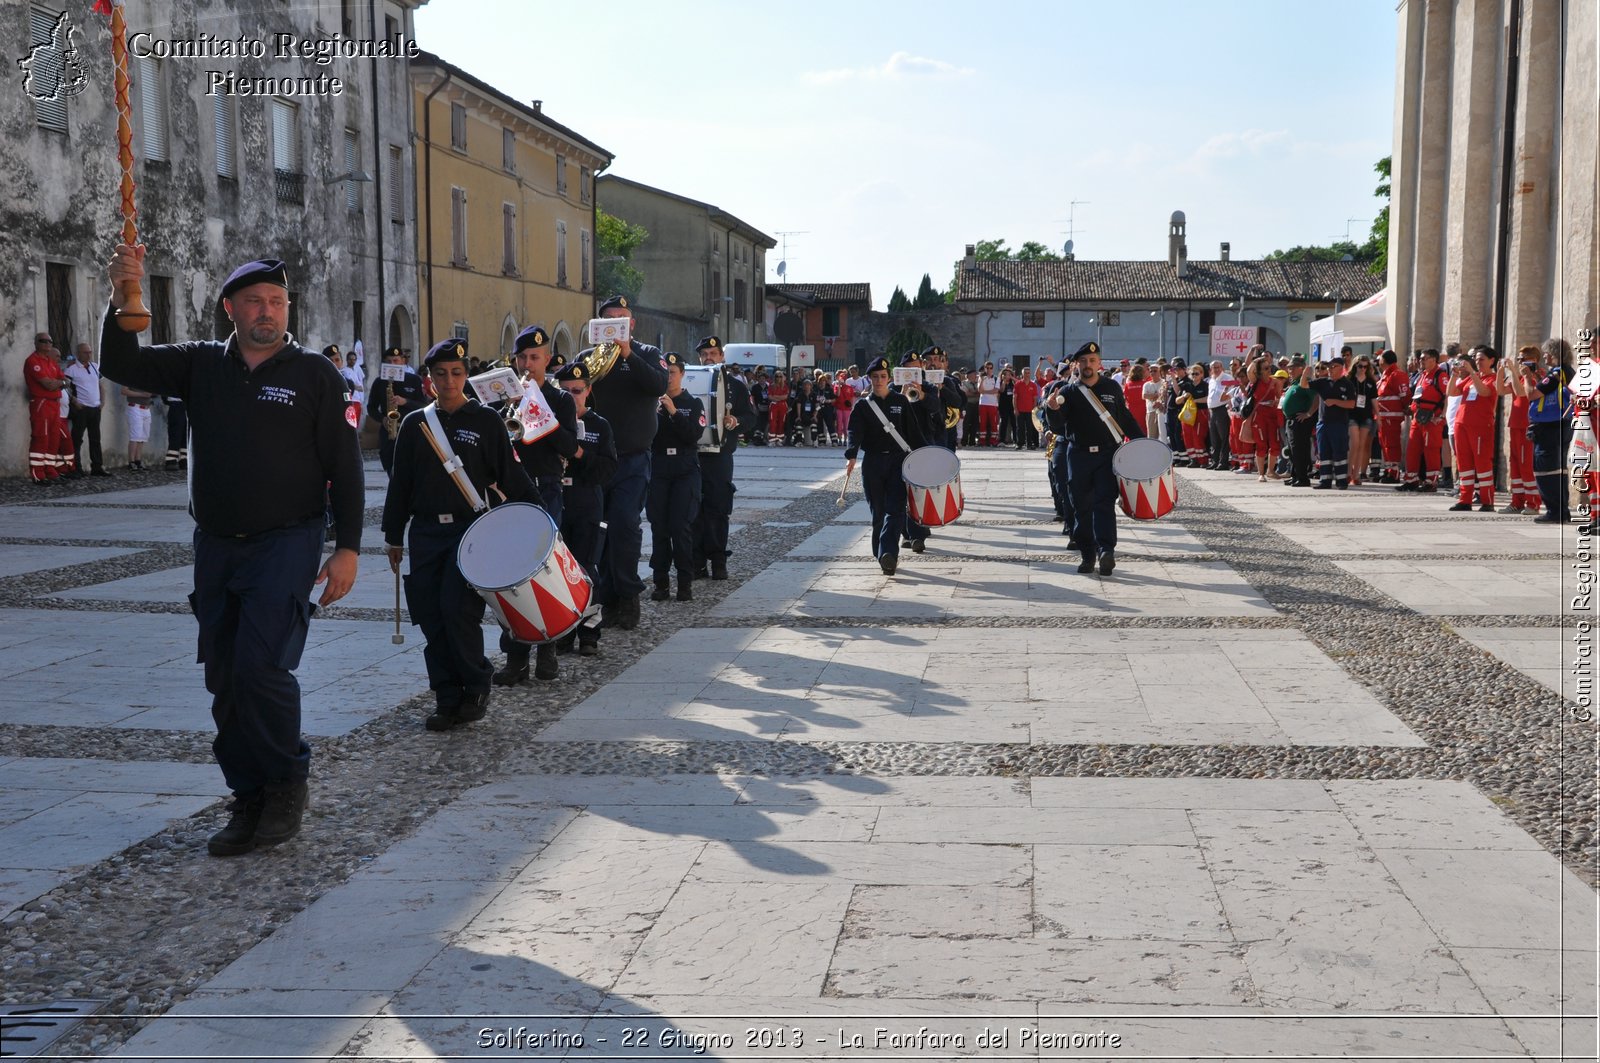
[{"left": 1389, "top": 0, "right": 1600, "bottom": 351}]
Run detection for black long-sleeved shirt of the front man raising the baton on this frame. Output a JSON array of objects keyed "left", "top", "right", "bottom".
[{"left": 101, "top": 312, "right": 365, "bottom": 551}]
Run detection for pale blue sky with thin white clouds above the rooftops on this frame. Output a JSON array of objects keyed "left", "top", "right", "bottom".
[{"left": 416, "top": 0, "right": 1397, "bottom": 307}]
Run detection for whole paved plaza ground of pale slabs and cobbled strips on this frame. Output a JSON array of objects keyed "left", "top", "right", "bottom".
[{"left": 0, "top": 450, "right": 1597, "bottom": 1060}]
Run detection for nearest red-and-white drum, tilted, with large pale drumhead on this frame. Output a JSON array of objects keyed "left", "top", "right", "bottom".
[{"left": 456, "top": 503, "right": 594, "bottom": 642}]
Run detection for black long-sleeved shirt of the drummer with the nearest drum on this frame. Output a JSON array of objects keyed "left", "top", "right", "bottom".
[{"left": 382, "top": 399, "right": 539, "bottom": 546}]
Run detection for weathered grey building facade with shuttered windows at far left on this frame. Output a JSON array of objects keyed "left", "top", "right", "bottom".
[{"left": 0, "top": 0, "right": 421, "bottom": 475}]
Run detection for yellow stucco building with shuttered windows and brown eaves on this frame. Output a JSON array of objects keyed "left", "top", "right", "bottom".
[{"left": 411, "top": 51, "right": 611, "bottom": 362}]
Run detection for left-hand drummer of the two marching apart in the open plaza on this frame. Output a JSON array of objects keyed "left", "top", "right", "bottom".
[{"left": 845, "top": 357, "right": 933, "bottom": 576}]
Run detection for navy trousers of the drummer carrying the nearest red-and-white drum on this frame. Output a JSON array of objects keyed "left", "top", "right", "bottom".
[{"left": 405, "top": 520, "right": 493, "bottom": 706}]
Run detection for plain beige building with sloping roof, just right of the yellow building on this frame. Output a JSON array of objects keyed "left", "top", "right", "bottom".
[{"left": 597, "top": 173, "right": 778, "bottom": 354}]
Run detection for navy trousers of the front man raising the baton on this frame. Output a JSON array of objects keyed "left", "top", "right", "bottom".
[{"left": 189, "top": 515, "right": 323, "bottom": 797}]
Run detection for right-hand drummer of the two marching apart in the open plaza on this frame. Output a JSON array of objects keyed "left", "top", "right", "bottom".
[{"left": 1058, "top": 341, "right": 1144, "bottom": 576}]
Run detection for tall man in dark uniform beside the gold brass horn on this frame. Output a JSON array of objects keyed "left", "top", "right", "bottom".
[{"left": 589, "top": 295, "right": 667, "bottom": 631}]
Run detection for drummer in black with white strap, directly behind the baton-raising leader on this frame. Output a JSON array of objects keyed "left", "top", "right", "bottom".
[{"left": 382, "top": 339, "right": 539, "bottom": 732}]
